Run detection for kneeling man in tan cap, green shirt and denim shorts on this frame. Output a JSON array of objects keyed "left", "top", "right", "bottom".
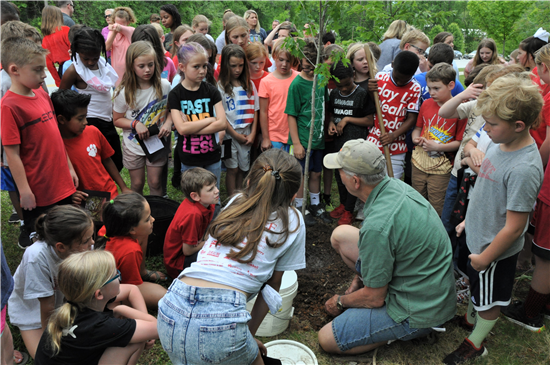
[{"left": 319, "top": 139, "right": 456, "bottom": 354}]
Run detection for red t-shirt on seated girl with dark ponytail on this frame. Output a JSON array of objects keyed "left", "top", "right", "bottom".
[{"left": 98, "top": 226, "right": 143, "bottom": 285}]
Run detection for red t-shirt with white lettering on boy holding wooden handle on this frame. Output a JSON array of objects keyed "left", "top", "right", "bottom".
[{"left": 367, "top": 72, "right": 421, "bottom": 155}]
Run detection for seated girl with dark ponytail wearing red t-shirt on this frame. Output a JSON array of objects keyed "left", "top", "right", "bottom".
[{"left": 98, "top": 193, "right": 166, "bottom": 309}]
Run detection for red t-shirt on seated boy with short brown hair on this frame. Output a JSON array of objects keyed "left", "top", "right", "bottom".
[{"left": 164, "top": 199, "right": 214, "bottom": 278}]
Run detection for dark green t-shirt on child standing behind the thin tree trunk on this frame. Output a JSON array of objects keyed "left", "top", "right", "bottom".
[{"left": 285, "top": 75, "right": 327, "bottom": 150}]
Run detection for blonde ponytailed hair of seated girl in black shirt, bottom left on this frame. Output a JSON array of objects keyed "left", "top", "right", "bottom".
[{"left": 47, "top": 250, "right": 116, "bottom": 356}]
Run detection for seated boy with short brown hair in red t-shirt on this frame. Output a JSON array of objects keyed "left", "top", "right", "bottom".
[{"left": 164, "top": 167, "right": 220, "bottom": 278}]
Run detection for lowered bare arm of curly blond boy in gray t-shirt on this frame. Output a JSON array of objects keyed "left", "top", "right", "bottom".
[{"left": 468, "top": 210, "right": 530, "bottom": 271}]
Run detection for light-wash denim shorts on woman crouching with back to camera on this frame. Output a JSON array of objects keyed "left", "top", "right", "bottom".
[{"left": 157, "top": 280, "right": 258, "bottom": 365}]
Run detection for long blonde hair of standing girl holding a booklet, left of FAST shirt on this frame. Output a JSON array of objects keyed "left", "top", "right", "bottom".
[{"left": 113, "top": 41, "right": 163, "bottom": 108}]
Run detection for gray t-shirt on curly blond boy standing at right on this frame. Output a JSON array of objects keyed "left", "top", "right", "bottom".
[{"left": 466, "top": 142, "right": 544, "bottom": 260}]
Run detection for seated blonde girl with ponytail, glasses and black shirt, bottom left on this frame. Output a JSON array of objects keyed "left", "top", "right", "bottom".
[{"left": 36, "top": 250, "right": 158, "bottom": 365}]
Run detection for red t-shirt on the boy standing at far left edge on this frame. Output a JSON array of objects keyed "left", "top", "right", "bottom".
[{"left": 1, "top": 89, "right": 76, "bottom": 207}]
